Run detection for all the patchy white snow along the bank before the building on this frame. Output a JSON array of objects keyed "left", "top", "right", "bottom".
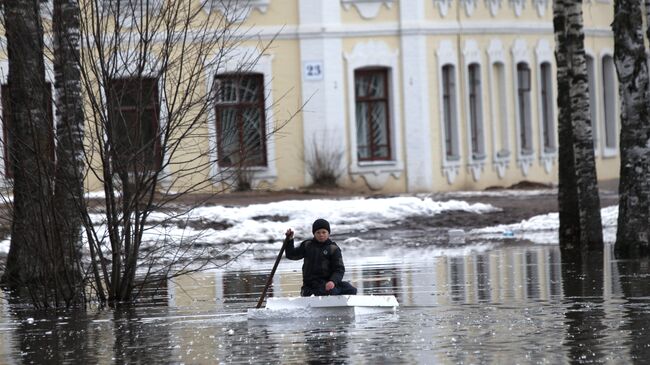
[{"left": 0, "top": 190, "right": 618, "bottom": 258}]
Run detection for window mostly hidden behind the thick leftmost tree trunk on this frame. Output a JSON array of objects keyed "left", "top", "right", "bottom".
[{"left": 1, "top": 82, "right": 55, "bottom": 178}]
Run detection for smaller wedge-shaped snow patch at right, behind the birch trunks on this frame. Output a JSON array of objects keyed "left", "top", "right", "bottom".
[{"left": 469, "top": 205, "right": 618, "bottom": 244}]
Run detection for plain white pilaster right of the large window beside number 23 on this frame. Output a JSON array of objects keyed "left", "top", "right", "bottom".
[{"left": 399, "top": 0, "right": 433, "bottom": 192}]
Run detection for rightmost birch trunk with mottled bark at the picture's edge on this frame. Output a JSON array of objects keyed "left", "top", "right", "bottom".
[{"left": 612, "top": 0, "right": 650, "bottom": 257}]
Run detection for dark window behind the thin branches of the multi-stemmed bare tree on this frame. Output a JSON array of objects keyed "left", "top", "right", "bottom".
[{"left": 108, "top": 78, "right": 161, "bottom": 172}]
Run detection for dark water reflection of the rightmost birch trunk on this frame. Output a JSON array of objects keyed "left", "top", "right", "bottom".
[{"left": 617, "top": 259, "right": 650, "bottom": 364}]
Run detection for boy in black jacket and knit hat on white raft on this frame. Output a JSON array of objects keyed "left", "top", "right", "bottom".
[{"left": 284, "top": 219, "right": 357, "bottom": 297}]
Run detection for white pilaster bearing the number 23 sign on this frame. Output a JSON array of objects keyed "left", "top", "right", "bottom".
[{"left": 298, "top": 0, "right": 347, "bottom": 184}]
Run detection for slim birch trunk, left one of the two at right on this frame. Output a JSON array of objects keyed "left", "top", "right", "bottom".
[{"left": 553, "top": 0, "right": 603, "bottom": 261}]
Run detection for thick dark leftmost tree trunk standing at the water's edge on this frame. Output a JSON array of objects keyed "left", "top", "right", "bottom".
[{"left": 3, "top": 0, "right": 70, "bottom": 305}]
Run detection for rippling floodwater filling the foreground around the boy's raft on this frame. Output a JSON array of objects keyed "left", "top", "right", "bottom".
[{"left": 0, "top": 242, "right": 650, "bottom": 364}]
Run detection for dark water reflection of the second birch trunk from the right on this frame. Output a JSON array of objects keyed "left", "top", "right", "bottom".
[{"left": 562, "top": 253, "right": 606, "bottom": 364}]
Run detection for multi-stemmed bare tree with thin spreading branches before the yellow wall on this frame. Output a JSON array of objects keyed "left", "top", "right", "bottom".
[{"left": 72, "top": 0, "right": 278, "bottom": 305}]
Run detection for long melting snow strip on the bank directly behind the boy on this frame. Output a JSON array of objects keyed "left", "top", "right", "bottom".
[{"left": 111, "top": 197, "right": 499, "bottom": 245}]
